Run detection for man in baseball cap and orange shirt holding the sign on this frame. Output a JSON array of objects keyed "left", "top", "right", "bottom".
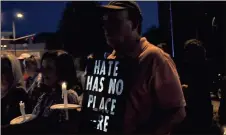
[{"left": 102, "top": 1, "right": 186, "bottom": 135}]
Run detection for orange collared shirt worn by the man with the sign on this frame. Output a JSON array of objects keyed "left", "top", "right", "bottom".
[{"left": 108, "top": 38, "right": 186, "bottom": 133}]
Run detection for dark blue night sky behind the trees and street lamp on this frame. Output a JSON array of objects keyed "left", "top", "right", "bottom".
[{"left": 1, "top": 1, "right": 158, "bottom": 36}]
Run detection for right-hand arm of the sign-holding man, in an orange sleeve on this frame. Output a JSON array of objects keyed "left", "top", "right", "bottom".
[{"left": 152, "top": 53, "right": 186, "bottom": 135}]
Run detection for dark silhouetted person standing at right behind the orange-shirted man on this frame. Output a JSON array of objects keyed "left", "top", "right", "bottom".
[{"left": 181, "top": 39, "right": 213, "bottom": 133}]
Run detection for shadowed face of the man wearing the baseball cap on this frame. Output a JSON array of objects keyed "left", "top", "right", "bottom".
[{"left": 103, "top": 10, "right": 132, "bottom": 51}]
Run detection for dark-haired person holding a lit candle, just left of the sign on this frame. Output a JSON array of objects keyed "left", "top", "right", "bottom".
[{"left": 8, "top": 50, "right": 81, "bottom": 134}]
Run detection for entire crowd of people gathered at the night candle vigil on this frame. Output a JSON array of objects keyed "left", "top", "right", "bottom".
[{"left": 1, "top": 1, "right": 226, "bottom": 135}]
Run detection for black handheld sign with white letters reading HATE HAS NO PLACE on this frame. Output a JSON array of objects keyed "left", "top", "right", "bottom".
[{"left": 81, "top": 59, "right": 135, "bottom": 133}]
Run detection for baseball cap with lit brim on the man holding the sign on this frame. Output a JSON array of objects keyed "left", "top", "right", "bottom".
[{"left": 101, "top": 1, "right": 142, "bottom": 18}]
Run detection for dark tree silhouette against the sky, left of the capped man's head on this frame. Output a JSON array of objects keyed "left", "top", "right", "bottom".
[{"left": 57, "top": 1, "right": 107, "bottom": 57}]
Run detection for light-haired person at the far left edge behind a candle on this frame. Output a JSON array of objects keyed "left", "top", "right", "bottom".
[{"left": 1, "top": 53, "right": 31, "bottom": 129}]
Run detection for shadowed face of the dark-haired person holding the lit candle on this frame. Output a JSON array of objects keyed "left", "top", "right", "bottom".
[{"left": 42, "top": 59, "right": 58, "bottom": 87}]
